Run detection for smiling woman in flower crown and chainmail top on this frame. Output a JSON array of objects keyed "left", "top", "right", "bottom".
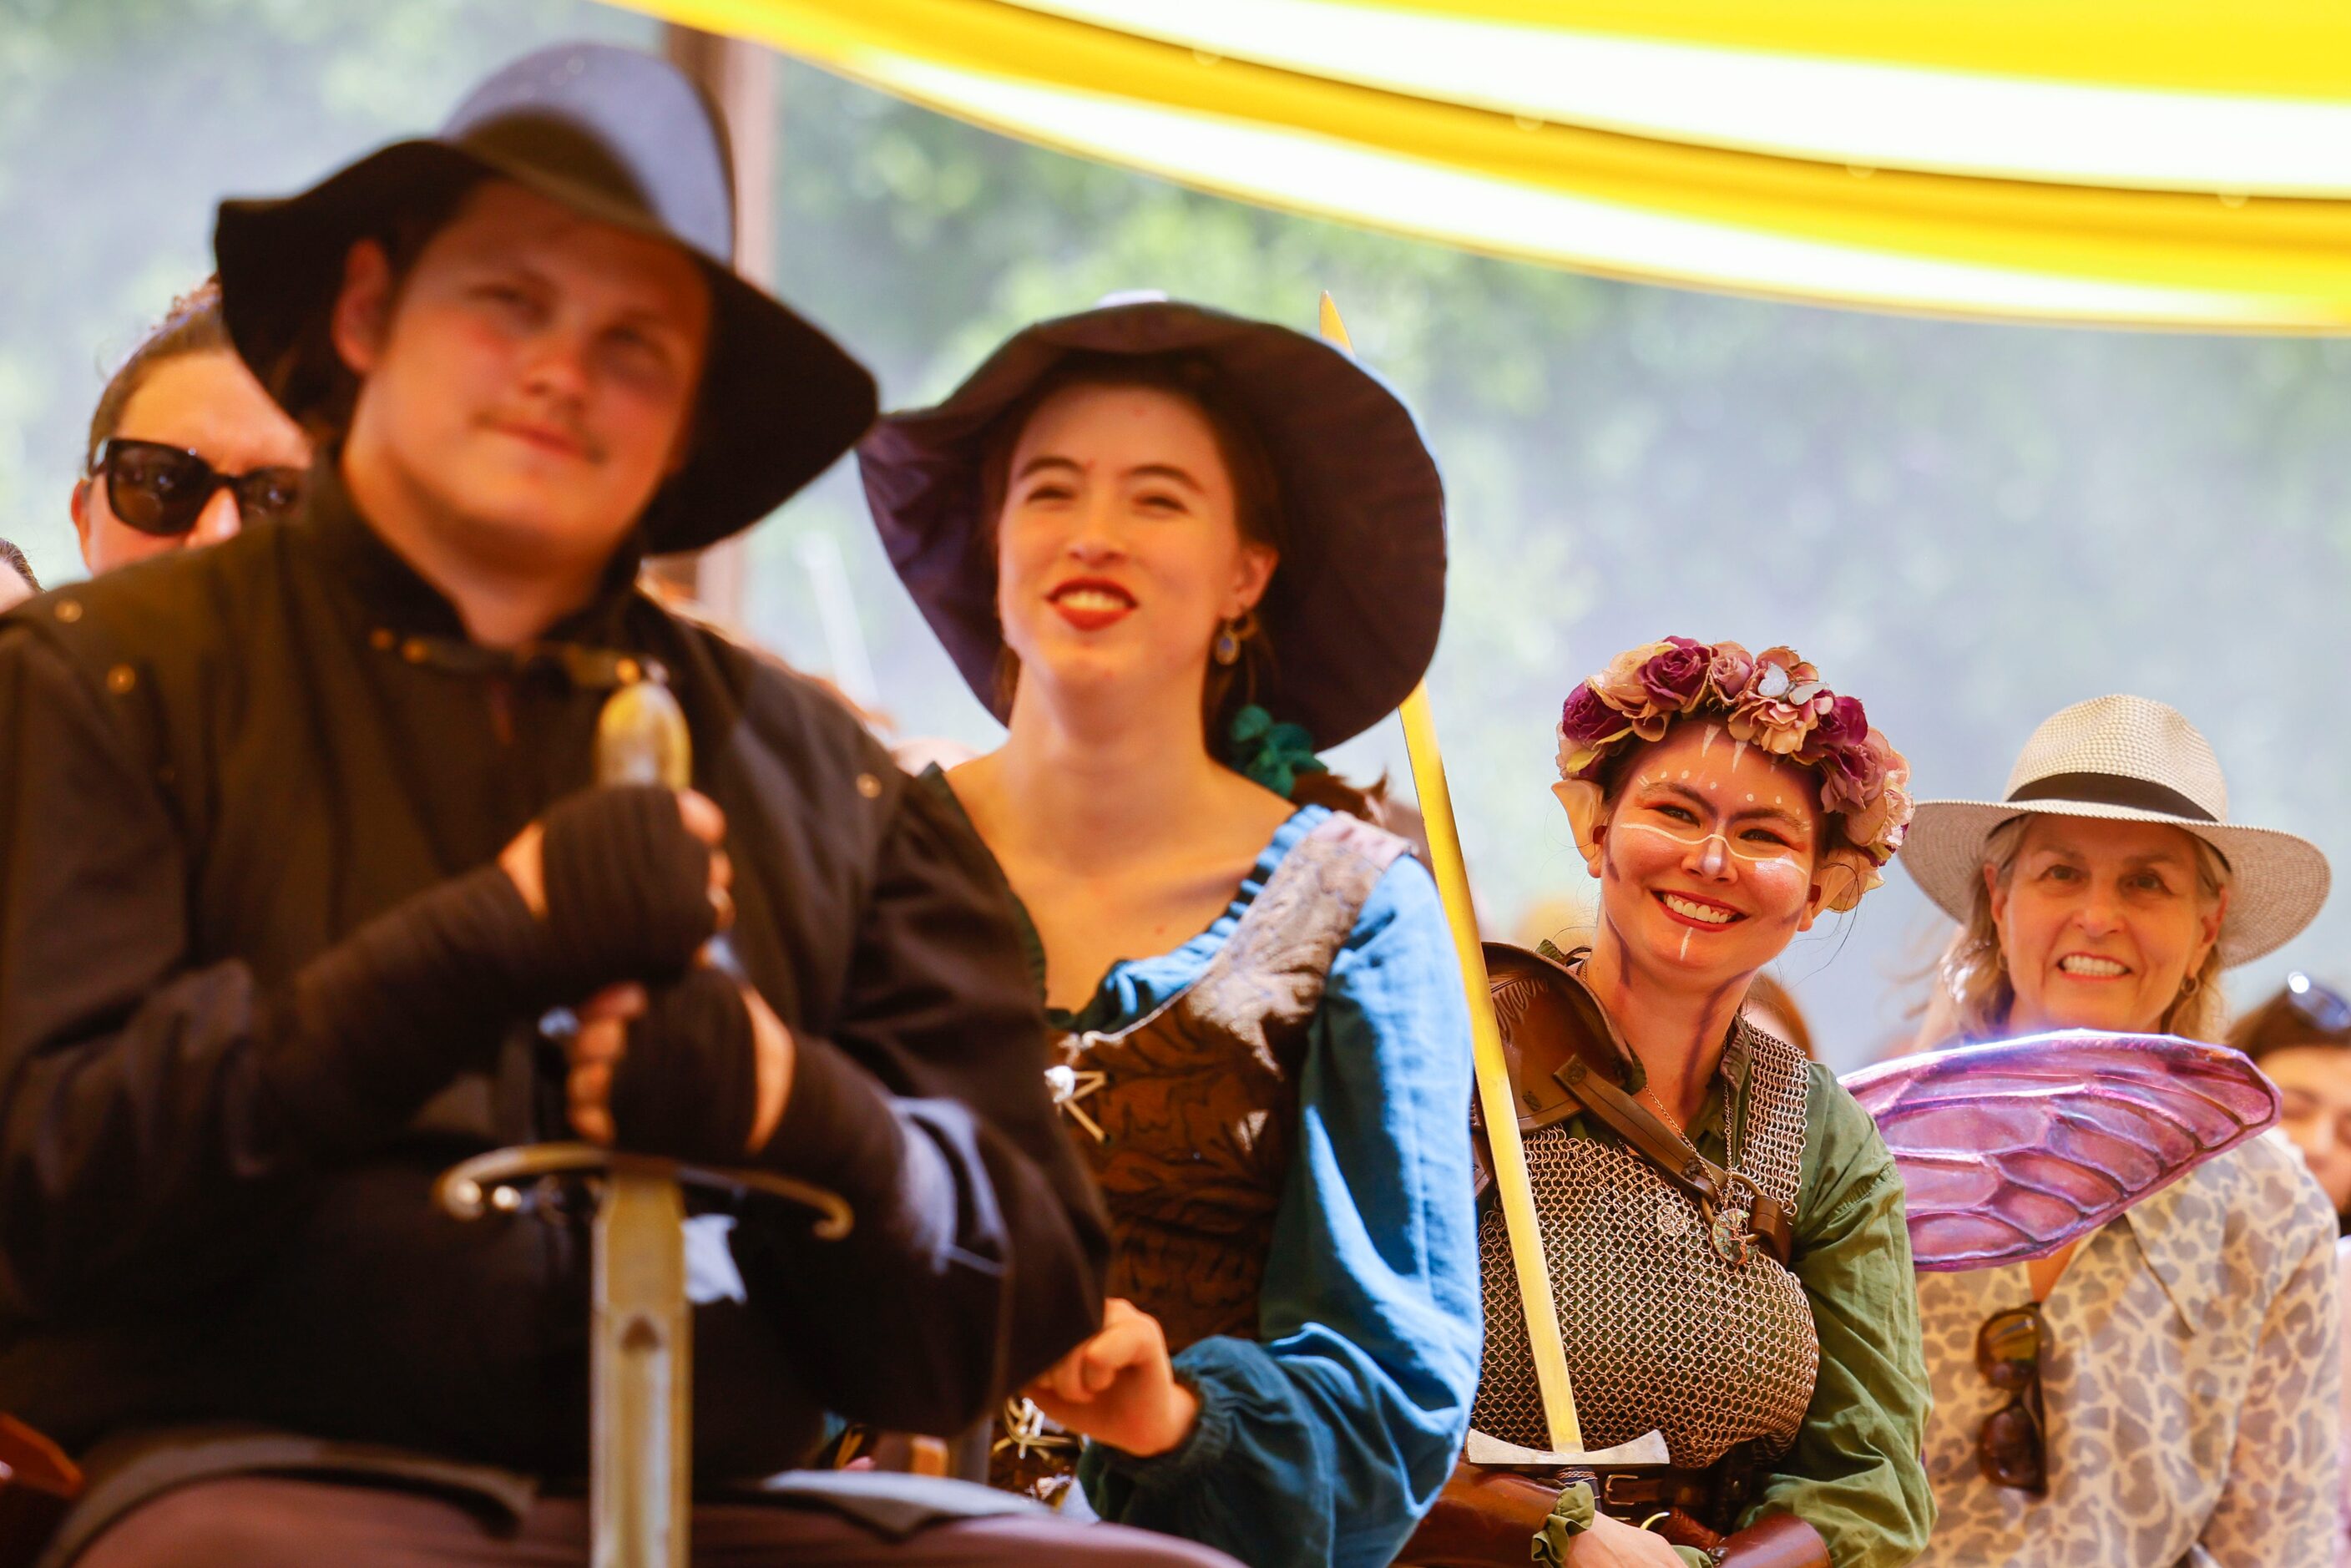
[{"left": 1406, "top": 637, "right": 1933, "bottom": 1568}]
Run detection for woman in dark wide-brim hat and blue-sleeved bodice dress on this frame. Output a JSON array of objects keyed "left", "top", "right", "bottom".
[{"left": 861, "top": 299, "right": 1479, "bottom": 1568}]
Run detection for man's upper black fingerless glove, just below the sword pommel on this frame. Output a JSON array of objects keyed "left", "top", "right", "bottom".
[{"left": 541, "top": 785, "right": 717, "bottom": 1006}]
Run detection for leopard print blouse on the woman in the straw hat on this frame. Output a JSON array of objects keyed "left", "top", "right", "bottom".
[{"left": 1919, "top": 1133, "right": 2342, "bottom": 1568}]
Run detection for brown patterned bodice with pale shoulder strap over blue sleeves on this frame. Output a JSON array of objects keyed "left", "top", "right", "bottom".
[{"left": 994, "top": 813, "right": 1406, "bottom": 1490}]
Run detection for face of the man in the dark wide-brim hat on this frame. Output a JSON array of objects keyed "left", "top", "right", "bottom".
[{"left": 334, "top": 181, "right": 710, "bottom": 583}]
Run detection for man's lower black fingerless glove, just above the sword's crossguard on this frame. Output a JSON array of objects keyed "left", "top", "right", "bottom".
[{"left": 611, "top": 969, "right": 760, "bottom": 1166}]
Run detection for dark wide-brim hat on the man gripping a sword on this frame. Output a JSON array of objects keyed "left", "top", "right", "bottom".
[{"left": 214, "top": 44, "right": 879, "bottom": 550}]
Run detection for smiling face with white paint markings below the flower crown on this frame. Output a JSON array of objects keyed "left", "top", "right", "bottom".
[{"left": 1591, "top": 720, "right": 1841, "bottom": 985}]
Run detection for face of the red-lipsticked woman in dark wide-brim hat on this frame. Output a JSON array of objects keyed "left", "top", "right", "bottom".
[{"left": 997, "top": 383, "right": 1274, "bottom": 724}]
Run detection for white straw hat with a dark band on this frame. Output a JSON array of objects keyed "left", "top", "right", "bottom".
[{"left": 1898, "top": 695, "right": 2330, "bottom": 966}]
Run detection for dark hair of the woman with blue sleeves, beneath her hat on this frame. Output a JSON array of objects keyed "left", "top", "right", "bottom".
[{"left": 980, "top": 352, "right": 1387, "bottom": 822}]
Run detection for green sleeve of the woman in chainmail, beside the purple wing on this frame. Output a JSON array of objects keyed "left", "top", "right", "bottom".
[{"left": 1740, "top": 1063, "right": 1935, "bottom": 1568}]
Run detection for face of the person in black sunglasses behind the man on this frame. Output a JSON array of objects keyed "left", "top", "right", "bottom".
[{"left": 73, "top": 348, "right": 311, "bottom": 576}]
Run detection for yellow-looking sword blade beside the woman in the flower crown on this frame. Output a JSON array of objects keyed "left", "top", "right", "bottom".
[{"left": 1322, "top": 291, "right": 1585, "bottom": 1462}]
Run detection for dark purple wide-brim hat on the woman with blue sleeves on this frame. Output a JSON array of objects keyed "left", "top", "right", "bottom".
[{"left": 858, "top": 299, "right": 1446, "bottom": 746}]
